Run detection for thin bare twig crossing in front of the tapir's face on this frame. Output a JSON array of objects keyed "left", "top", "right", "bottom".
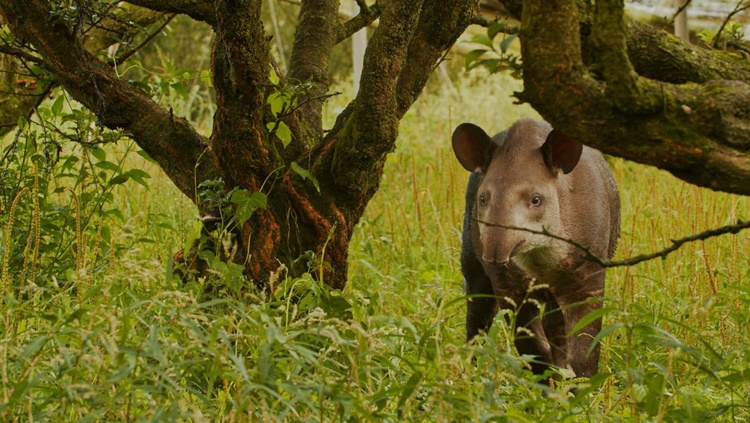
[{"left": 474, "top": 219, "right": 750, "bottom": 267}]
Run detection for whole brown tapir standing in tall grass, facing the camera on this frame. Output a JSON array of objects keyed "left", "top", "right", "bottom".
[{"left": 452, "top": 119, "right": 620, "bottom": 378}]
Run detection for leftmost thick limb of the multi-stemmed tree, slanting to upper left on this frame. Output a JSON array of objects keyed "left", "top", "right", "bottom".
[{"left": 0, "top": 0, "right": 219, "bottom": 200}]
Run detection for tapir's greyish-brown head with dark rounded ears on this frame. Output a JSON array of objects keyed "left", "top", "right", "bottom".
[{"left": 453, "top": 119, "right": 583, "bottom": 265}]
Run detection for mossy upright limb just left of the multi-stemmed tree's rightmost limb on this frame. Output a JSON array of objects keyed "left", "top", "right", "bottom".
[{"left": 322, "top": 0, "right": 423, "bottom": 217}]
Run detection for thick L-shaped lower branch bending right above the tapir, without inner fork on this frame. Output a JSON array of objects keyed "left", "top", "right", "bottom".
[{"left": 519, "top": 0, "right": 750, "bottom": 195}]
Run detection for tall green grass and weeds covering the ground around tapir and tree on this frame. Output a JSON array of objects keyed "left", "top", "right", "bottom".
[{"left": 0, "top": 69, "right": 750, "bottom": 422}]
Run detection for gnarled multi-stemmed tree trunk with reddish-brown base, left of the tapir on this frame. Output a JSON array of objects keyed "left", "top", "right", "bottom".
[{"left": 0, "top": 0, "right": 476, "bottom": 288}]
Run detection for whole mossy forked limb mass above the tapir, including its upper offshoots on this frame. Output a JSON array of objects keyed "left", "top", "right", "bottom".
[{"left": 502, "top": 0, "right": 750, "bottom": 195}]
